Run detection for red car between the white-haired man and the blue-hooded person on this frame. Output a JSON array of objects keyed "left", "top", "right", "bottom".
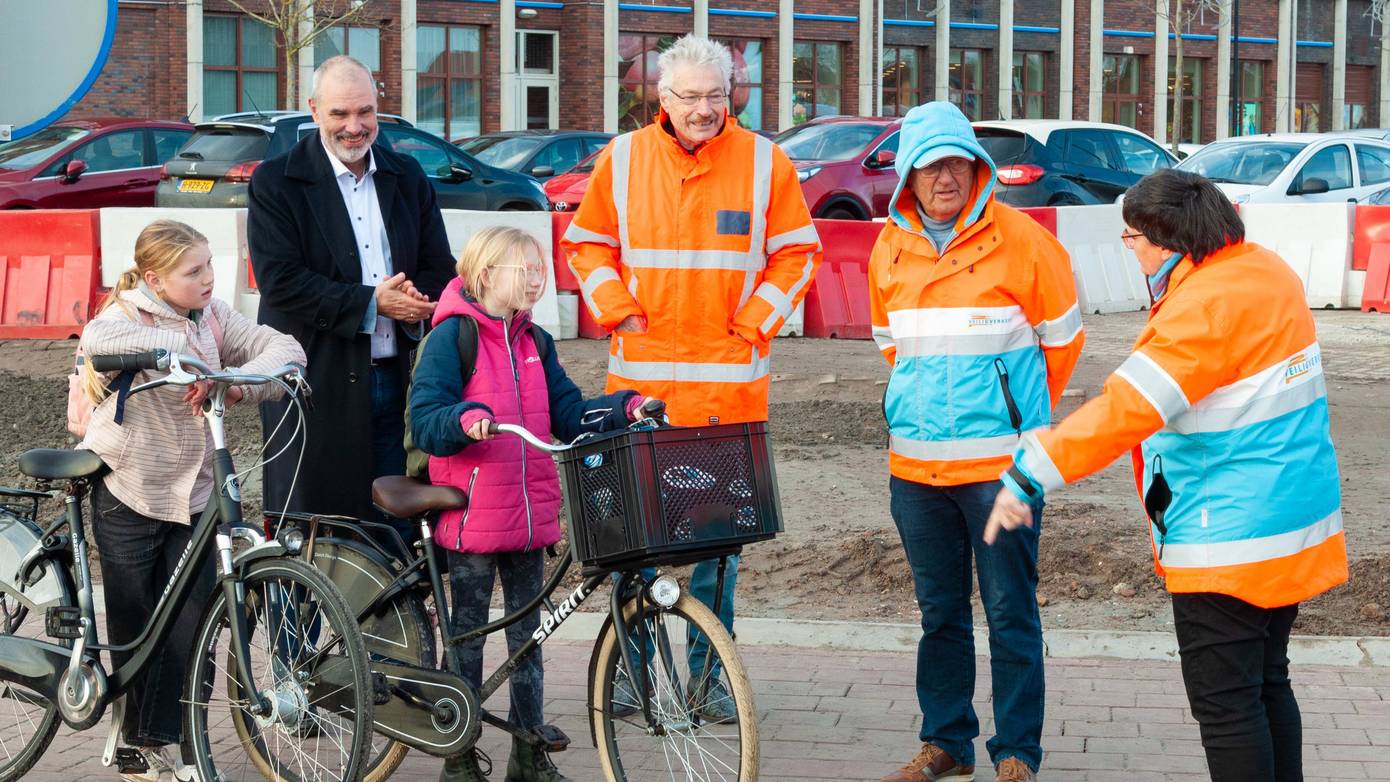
[{"left": 773, "top": 117, "right": 901, "bottom": 219}]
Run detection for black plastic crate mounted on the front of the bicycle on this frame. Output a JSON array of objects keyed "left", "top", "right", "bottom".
[{"left": 560, "top": 422, "right": 783, "bottom": 569}]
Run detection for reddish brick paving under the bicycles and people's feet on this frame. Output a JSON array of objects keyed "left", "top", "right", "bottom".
[{"left": 26, "top": 642, "right": 1390, "bottom": 782}]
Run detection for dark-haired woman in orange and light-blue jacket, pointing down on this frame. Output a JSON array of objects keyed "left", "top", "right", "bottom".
[{"left": 986, "top": 169, "right": 1347, "bottom": 782}]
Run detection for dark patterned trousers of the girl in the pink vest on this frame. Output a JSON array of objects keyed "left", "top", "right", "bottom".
[{"left": 449, "top": 551, "right": 545, "bottom": 728}]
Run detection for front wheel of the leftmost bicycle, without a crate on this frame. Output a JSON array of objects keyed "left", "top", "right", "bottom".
[{"left": 183, "top": 558, "right": 373, "bottom": 782}]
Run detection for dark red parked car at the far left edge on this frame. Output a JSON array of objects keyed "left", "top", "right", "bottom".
[{"left": 0, "top": 118, "right": 193, "bottom": 210}]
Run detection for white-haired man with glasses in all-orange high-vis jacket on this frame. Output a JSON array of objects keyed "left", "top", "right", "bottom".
[{"left": 560, "top": 36, "right": 821, "bottom": 722}]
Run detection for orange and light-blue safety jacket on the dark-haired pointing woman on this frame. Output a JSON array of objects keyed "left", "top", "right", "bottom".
[{"left": 1006, "top": 242, "right": 1347, "bottom": 608}]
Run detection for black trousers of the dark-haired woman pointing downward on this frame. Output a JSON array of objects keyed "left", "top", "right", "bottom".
[{"left": 1173, "top": 593, "right": 1302, "bottom": 782}]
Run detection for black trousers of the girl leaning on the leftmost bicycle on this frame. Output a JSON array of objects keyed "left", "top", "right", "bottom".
[{"left": 92, "top": 481, "right": 215, "bottom": 746}]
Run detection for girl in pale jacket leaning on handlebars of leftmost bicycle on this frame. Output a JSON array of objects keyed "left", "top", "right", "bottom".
[{"left": 79, "top": 219, "right": 304, "bottom": 782}]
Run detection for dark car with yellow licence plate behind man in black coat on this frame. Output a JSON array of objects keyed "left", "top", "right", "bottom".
[{"left": 154, "top": 111, "right": 550, "bottom": 211}]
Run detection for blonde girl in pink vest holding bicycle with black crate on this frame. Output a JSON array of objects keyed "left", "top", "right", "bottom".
[{"left": 409, "top": 226, "right": 658, "bottom": 782}]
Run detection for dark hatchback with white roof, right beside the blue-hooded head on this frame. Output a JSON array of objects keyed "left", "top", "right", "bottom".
[{"left": 974, "top": 119, "right": 1177, "bottom": 207}]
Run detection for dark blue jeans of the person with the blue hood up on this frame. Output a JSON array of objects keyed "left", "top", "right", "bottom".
[{"left": 888, "top": 476, "right": 1043, "bottom": 771}]
